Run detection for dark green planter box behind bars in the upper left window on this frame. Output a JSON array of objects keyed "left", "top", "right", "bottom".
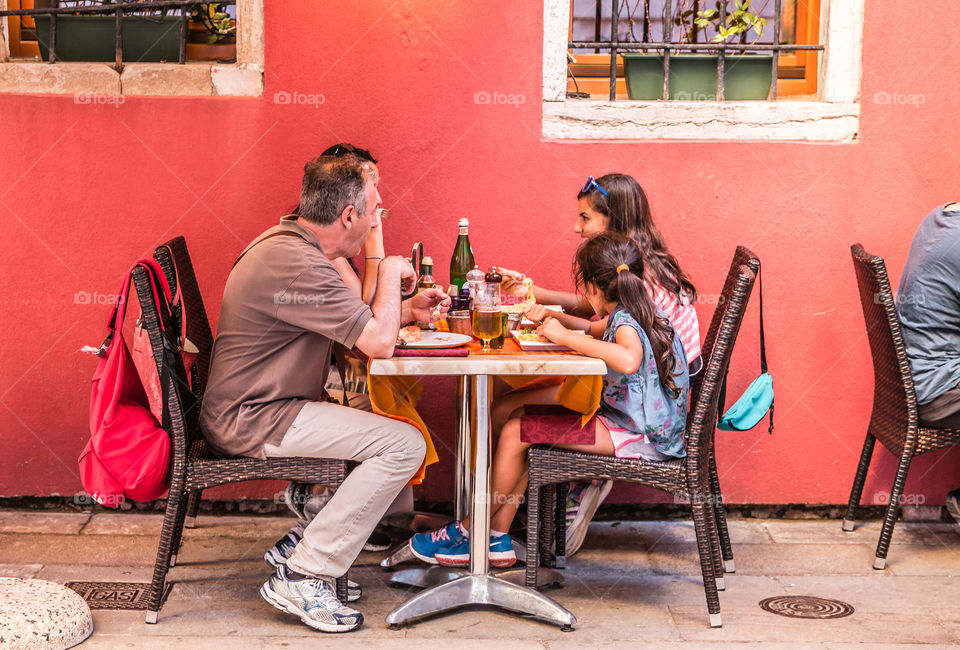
[{"left": 35, "top": 16, "right": 181, "bottom": 63}]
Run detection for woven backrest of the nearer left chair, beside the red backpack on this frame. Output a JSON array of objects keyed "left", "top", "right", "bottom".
[{"left": 133, "top": 266, "right": 200, "bottom": 466}]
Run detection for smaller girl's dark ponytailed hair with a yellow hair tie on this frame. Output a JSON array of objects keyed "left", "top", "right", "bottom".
[{"left": 573, "top": 232, "right": 680, "bottom": 396}]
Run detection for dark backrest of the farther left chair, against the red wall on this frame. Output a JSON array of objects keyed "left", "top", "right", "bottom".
[{"left": 153, "top": 237, "right": 213, "bottom": 396}]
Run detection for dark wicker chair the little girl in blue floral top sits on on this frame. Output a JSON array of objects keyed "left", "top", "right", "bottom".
[{"left": 526, "top": 265, "right": 756, "bottom": 627}]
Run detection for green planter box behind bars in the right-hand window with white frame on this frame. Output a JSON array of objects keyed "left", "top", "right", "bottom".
[{"left": 622, "top": 52, "right": 773, "bottom": 101}]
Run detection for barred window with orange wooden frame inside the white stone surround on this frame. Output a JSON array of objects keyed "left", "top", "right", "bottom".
[{"left": 567, "top": 0, "right": 824, "bottom": 100}]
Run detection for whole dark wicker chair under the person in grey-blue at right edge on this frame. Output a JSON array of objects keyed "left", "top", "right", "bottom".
[{"left": 843, "top": 244, "right": 960, "bottom": 569}]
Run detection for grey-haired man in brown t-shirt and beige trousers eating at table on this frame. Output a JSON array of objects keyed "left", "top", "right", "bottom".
[{"left": 200, "top": 156, "right": 450, "bottom": 632}]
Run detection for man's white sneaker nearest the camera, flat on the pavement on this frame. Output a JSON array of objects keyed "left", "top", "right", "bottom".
[{"left": 260, "top": 567, "right": 363, "bottom": 632}]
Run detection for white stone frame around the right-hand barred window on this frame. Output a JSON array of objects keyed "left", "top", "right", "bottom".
[{"left": 542, "top": 0, "right": 864, "bottom": 142}]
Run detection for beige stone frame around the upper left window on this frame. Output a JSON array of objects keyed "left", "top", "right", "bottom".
[{"left": 0, "top": 0, "right": 264, "bottom": 98}]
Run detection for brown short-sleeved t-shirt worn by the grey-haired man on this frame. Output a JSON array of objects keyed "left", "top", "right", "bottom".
[{"left": 200, "top": 218, "right": 373, "bottom": 458}]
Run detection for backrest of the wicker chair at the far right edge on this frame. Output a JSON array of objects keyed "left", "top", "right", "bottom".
[{"left": 850, "top": 244, "right": 917, "bottom": 436}]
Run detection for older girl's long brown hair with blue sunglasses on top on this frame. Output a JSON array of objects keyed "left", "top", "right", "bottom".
[{"left": 577, "top": 174, "right": 697, "bottom": 301}]
